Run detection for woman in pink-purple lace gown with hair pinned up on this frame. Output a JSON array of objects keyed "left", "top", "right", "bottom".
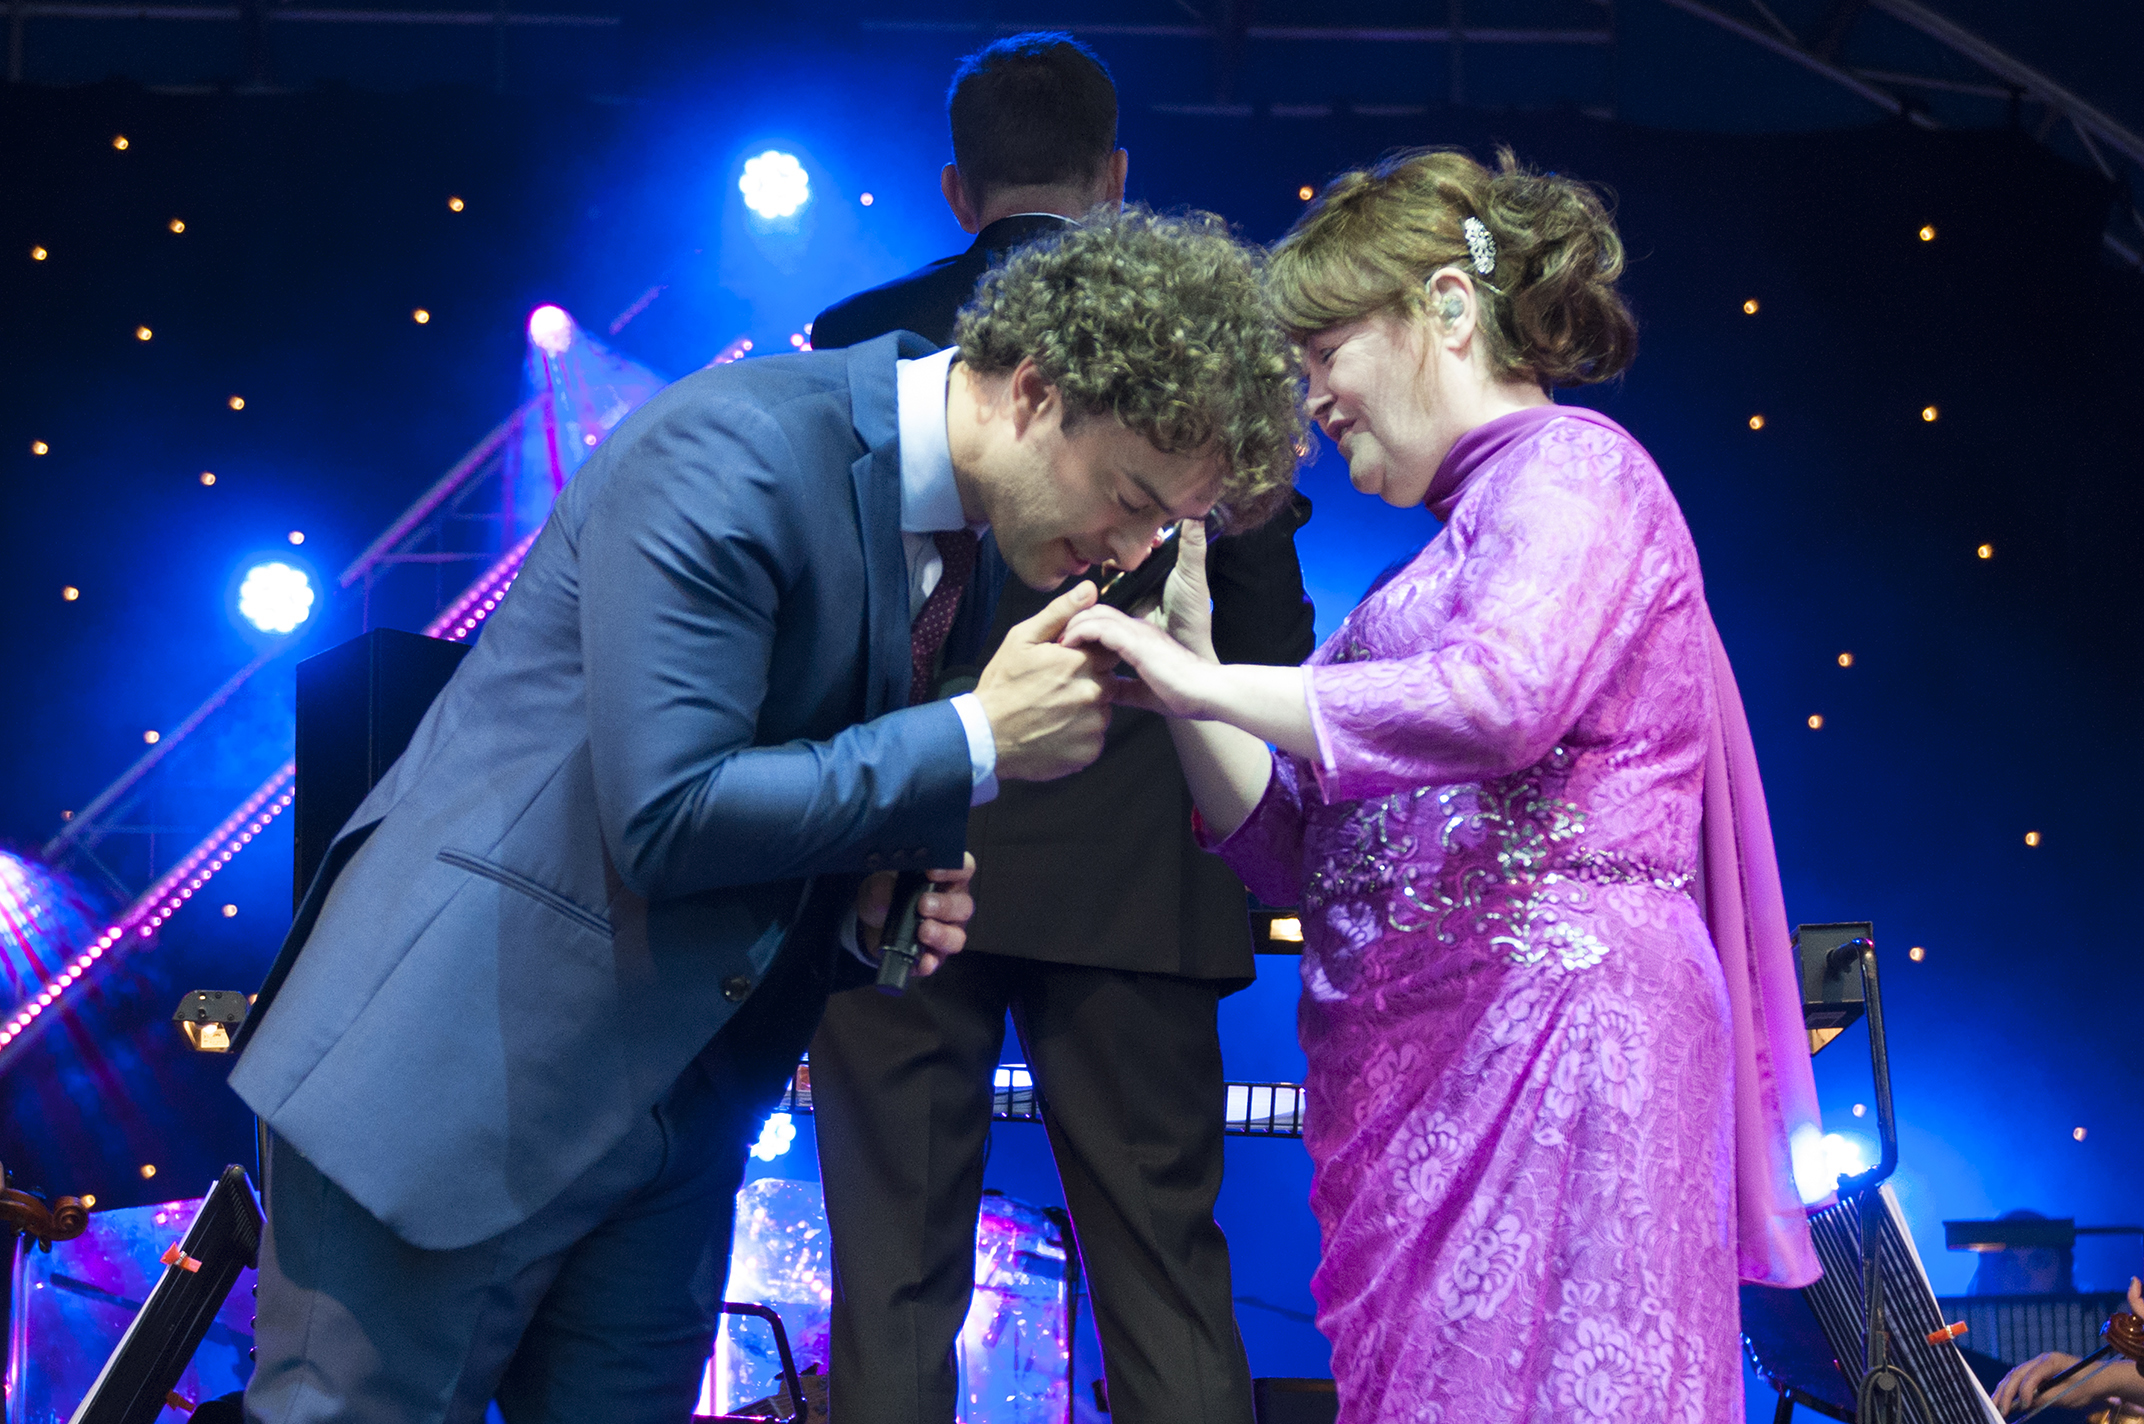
[{"left": 1068, "top": 152, "right": 1818, "bottom": 1424}]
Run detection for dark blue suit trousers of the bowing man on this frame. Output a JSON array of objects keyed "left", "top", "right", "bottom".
[{"left": 247, "top": 935, "right": 825, "bottom": 1424}]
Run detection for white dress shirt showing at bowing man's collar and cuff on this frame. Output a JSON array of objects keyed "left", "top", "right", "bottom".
[{"left": 894, "top": 345, "right": 997, "bottom": 806}]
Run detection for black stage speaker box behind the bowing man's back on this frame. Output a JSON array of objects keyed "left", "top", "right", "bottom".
[{"left": 289, "top": 628, "right": 470, "bottom": 907}]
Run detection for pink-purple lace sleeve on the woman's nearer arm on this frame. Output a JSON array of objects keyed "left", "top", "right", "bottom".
[{"left": 1306, "top": 440, "right": 1677, "bottom": 802}]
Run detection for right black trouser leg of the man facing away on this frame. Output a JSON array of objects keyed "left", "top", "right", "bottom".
[{"left": 1012, "top": 963, "right": 1252, "bottom": 1424}]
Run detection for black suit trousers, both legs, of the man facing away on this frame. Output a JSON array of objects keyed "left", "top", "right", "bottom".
[{"left": 810, "top": 950, "right": 1252, "bottom": 1424}]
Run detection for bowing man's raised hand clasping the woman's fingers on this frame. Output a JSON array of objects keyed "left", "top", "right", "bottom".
[{"left": 976, "top": 581, "right": 1117, "bottom": 781}]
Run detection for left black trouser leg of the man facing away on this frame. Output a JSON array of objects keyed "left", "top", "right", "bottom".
[{"left": 810, "top": 950, "right": 1016, "bottom": 1424}]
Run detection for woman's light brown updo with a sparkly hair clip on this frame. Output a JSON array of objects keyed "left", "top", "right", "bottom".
[{"left": 1267, "top": 148, "right": 1638, "bottom": 388}]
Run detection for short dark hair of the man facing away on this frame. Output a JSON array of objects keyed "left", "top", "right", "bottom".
[{"left": 946, "top": 30, "right": 1117, "bottom": 202}]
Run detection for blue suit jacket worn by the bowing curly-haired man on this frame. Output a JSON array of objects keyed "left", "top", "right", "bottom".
[{"left": 232, "top": 335, "right": 971, "bottom": 1248}]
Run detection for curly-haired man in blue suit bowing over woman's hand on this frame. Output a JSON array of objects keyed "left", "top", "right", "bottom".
[{"left": 232, "top": 202, "right": 1301, "bottom": 1424}]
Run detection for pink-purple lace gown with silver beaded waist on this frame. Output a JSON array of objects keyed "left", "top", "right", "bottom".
[{"left": 1216, "top": 407, "right": 1766, "bottom": 1424}]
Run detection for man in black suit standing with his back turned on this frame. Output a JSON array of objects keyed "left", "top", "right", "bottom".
[{"left": 810, "top": 34, "right": 1312, "bottom": 1424}]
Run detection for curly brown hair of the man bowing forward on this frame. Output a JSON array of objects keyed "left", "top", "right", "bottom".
[{"left": 952, "top": 206, "right": 1306, "bottom": 528}]
